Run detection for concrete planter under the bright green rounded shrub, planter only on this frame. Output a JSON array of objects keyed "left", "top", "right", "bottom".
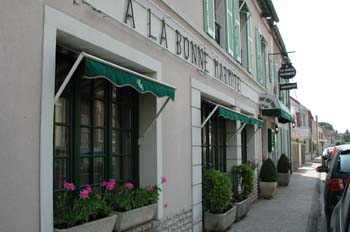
[{"left": 204, "top": 206, "right": 236, "bottom": 231}]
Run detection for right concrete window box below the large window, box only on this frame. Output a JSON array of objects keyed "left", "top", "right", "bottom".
[{"left": 112, "top": 204, "right": 158, "bottom": 231}]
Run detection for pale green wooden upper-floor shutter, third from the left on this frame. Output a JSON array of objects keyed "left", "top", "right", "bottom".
[{"left": 232, "top": 0, "right": 242, "bottom": 63}]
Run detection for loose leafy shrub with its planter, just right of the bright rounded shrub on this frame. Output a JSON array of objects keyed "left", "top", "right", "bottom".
[{"left": 231, "top": 164, "right": 255, "bottom": 221}]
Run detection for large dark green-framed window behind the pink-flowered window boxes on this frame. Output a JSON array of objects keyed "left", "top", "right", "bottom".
[{"left": 54, "top": 48, "right": 138, "bottom": 190}]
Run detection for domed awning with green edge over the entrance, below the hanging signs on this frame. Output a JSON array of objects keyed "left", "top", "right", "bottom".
[{"left": 260, "top": 95, "right": 293, "bottom": 123}]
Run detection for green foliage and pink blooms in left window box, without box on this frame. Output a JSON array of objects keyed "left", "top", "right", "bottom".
[{"left": 54, "top": 183, "right": 112, "bottom": 229}]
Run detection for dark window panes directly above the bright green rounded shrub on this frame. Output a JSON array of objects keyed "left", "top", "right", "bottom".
[{"left": 201, "top": 101, "right": 226, "bottom": 172}]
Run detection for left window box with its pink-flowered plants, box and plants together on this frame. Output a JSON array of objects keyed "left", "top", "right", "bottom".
[{"left": 54, "top": 183, "right": 117, "bottom": 232}]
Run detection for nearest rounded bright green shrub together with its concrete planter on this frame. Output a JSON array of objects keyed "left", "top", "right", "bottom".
[{"left": 203, "top": 169, "right": 236, "bottom": 231}]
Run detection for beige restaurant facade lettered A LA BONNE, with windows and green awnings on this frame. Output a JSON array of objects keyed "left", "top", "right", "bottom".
[{"left": 0, "top": 0, "right": 292, "bottom": 232}]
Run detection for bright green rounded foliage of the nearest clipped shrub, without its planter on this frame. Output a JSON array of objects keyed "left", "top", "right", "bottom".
[{"left": 203, "top": 169, "right": 232, "bottom": 214}]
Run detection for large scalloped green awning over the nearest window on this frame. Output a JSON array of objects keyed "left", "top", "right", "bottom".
[{"left": 82, "top": 56, "right": 175, "bottom": 100}]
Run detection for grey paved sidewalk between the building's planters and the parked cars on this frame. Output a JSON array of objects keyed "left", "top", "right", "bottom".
[{"left": 228, "top": 160, "right": 320, "bottom": 232}]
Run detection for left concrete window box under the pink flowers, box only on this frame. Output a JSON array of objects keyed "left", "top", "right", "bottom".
[{"left": 54, "top": 215, "right": 117, "bottom": 232}]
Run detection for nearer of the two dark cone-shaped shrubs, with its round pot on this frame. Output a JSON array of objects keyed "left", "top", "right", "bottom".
[{"left": 259, "top": 158, "right": 277, "bottom": 199}]
